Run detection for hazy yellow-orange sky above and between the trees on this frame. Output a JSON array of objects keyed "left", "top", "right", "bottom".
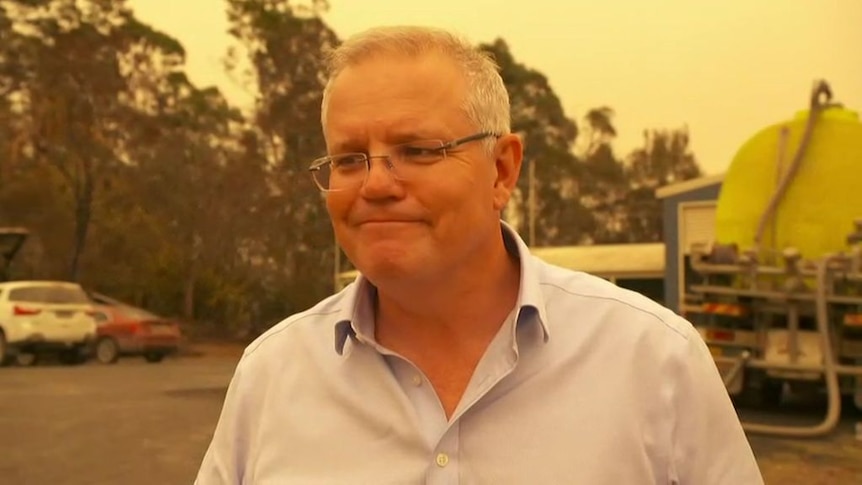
[{"left": 129, "top": 0, "right": 862, "bottom": 173}]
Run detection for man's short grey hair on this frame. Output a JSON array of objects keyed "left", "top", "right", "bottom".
[{"left": 320, "top": 26, "right": 511, "bottom": 147}]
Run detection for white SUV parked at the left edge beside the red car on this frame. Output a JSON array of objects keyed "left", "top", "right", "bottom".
[{"left": 0, "top": 281, "right": 96, "bottom": 365}]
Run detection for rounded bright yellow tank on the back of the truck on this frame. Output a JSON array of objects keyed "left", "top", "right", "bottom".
[{"left": 716, "top": 106, "right": 862, "bottom": 260}]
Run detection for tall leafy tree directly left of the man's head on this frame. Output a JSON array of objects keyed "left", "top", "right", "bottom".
[{"left": 227, "top": 0, "right": 338, "bottom": 314}]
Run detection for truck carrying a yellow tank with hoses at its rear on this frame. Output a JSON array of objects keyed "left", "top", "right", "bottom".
[{"left": 686, "top": 80, "right": 862, "bottom": 437}]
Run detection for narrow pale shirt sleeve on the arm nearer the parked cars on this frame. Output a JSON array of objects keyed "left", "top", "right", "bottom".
[{"left": 194, "top": 360, "right": 250, "bottom": 485}]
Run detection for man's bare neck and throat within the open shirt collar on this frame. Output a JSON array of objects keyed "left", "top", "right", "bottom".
[{"left": 375, "top": 240, "right": 520, "bottom": 418}]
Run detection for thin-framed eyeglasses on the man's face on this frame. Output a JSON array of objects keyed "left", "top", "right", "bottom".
[{"left": 308, "top": 132, "right": 499, "bottom": 192}]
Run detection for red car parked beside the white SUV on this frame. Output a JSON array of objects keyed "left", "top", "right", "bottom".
[{"left": 90, "top": 292, "right": 182, "bottom": 364}]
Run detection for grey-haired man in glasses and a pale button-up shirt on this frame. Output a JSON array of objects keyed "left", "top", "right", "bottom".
[{"left": 197, "top": 27, "right": 762, "bottom": 485}]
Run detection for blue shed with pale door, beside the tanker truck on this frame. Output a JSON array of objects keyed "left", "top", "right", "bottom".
[{"left": 655, "top": 174, "right": 724, "bottom": 314}]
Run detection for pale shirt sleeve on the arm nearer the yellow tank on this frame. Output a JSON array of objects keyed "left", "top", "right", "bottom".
[{"left": 670, "top": 321, "right": 763, "bottom": 485}]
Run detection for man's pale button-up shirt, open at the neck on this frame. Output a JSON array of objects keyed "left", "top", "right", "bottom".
[{"left": 196, "top": 224, "right": 763, "bottom": 485}]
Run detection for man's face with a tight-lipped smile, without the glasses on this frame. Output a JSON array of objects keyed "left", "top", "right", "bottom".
[{"left": 324, "top": 55, "right": 508, "bottom": 284}]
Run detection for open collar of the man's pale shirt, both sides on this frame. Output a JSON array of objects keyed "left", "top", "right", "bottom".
[{"left": 335, "top": 221, "right": 550, "bottom": 355}]
